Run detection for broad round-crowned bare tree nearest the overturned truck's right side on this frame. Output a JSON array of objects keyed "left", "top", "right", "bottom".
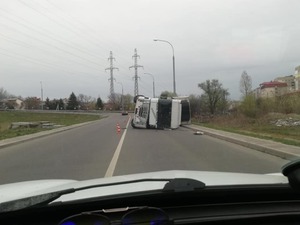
[{"left": 198, "top": 79, "right": 229, "bottom": 114}]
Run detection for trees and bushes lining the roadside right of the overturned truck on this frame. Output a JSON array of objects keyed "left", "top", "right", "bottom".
[{"left": 189, "top": 71, "right": 300, "bottom": 118}]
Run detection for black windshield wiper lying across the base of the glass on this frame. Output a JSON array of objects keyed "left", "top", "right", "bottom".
[{"left": 0, "top": 178, "right": 205, "bottom": 213}]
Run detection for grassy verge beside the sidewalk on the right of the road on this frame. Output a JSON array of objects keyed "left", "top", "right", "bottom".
[{"left": 193, "top": 114, "right": 300, "bottom": 147}]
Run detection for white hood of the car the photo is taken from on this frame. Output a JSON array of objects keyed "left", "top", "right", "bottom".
[{"left": 0, "top": 170, "right": 288, "bottom": 203}]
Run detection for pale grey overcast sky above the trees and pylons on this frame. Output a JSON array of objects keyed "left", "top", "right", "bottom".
[{"left": 0, "top": 0, "right": 300, "bottom": 100}]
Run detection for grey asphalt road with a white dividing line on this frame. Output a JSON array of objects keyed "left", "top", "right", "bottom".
[{"left": 0, "top": 114, "right": 287, "bottom": 184}]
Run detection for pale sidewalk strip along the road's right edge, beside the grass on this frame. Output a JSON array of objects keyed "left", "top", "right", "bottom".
[{"left": 184, "top": 124, "right": 300, "bottom": 160}]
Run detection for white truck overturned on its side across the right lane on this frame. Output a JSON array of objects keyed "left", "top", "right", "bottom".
[{"left": 131, "top": 95, "right": 191, "bottom": 129}]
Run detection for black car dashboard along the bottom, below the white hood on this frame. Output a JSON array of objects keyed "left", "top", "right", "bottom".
[{"left": 0, "top": 184, "right": 300, "bottom": 225}]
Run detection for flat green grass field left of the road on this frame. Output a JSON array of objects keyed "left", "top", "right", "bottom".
[{"left": 0, "top": 111, "right": 100, "bottom": 140}]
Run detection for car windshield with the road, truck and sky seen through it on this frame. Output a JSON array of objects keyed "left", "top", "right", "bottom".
[{"left": 0, "top": 0, "right": 300, "bottom": 190}]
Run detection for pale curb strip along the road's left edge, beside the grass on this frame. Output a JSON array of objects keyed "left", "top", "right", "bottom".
[{"left": 0, "top": 120, "right": 98, "bottom": 149}]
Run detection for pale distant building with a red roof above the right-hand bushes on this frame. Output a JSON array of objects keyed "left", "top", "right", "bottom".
[{"left": 259, "top": 81, "right": 288, "bottom": 98}]
